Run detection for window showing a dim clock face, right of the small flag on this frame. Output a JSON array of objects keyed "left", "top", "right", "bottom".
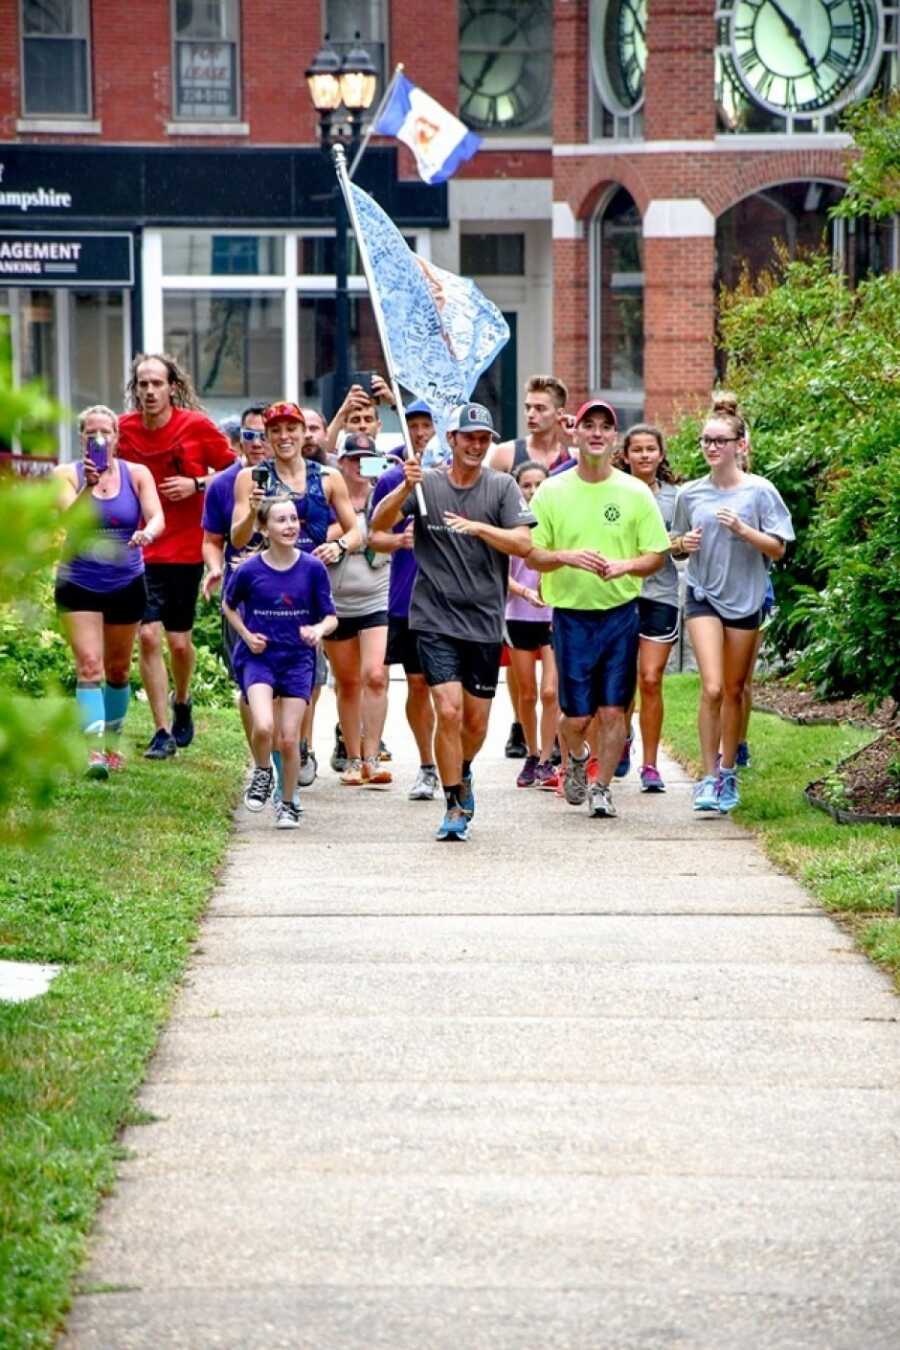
[{"left": 459, "top": 0, "right": 553, "bottom": 131}]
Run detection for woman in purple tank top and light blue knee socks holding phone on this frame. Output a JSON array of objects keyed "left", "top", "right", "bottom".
[{"left": 54, "top": 405, "right": 166, "bottom": 778}]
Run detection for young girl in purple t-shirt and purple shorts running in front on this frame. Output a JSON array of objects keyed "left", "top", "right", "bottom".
[{"left": 223, "top": 497, "right": 337, "bottom": 829}]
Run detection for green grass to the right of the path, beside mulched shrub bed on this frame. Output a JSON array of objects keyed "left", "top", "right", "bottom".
[{"left": 663, "top": 675, "right": 900, "bottom": 987}]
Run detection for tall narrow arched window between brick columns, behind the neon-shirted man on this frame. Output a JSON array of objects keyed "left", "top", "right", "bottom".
[{"left": 591, "top": 188, "right": 644, "bottom": 427}]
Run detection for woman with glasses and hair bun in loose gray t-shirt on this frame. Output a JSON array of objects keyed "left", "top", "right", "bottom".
[{"left": 672, "top": 413, "right": 793, "bottom": 813}]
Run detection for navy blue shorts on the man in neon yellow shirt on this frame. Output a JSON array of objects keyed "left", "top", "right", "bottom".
[{"left": 553, "top": 599, "right": 640, "bottom": 717}]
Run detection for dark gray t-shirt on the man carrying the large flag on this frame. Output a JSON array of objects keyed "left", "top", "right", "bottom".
[{"left": 401, "top": 466, "right": 537, "bottom": 643}]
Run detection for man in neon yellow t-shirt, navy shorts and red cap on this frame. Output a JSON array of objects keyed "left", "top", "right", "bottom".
[{"left": 526, "top": 398, "right": 669, "bottom": 817}]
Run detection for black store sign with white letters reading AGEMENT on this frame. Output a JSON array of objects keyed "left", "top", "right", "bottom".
[{"left": 0, "top": 230, "right": 135, "bottom": 286}]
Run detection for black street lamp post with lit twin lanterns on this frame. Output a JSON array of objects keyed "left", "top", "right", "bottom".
[{"left": 306, "top": 34, "right": 378, "bottom": 400}]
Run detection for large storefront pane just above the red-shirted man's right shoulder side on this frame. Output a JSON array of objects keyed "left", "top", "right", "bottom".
[{"left": 163, "top": 290, "right": 283, "bottom": 416}]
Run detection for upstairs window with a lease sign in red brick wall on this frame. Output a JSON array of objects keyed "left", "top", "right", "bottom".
[{"left": 174, "top": 0, "right": 239, "bottom": 122}]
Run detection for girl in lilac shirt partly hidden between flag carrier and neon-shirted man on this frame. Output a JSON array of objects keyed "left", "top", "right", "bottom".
[{"left": 506, "top": 459, "right": 560, "bottom": 791}]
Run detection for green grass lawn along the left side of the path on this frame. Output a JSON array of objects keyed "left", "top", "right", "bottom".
[{"left": 0, "top": 707, "right": 246, "bottom": 1347}]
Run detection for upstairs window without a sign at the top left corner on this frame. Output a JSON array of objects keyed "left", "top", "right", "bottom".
[{"left": 22, "top": 0, "right": 90, "bottom": 117}]
